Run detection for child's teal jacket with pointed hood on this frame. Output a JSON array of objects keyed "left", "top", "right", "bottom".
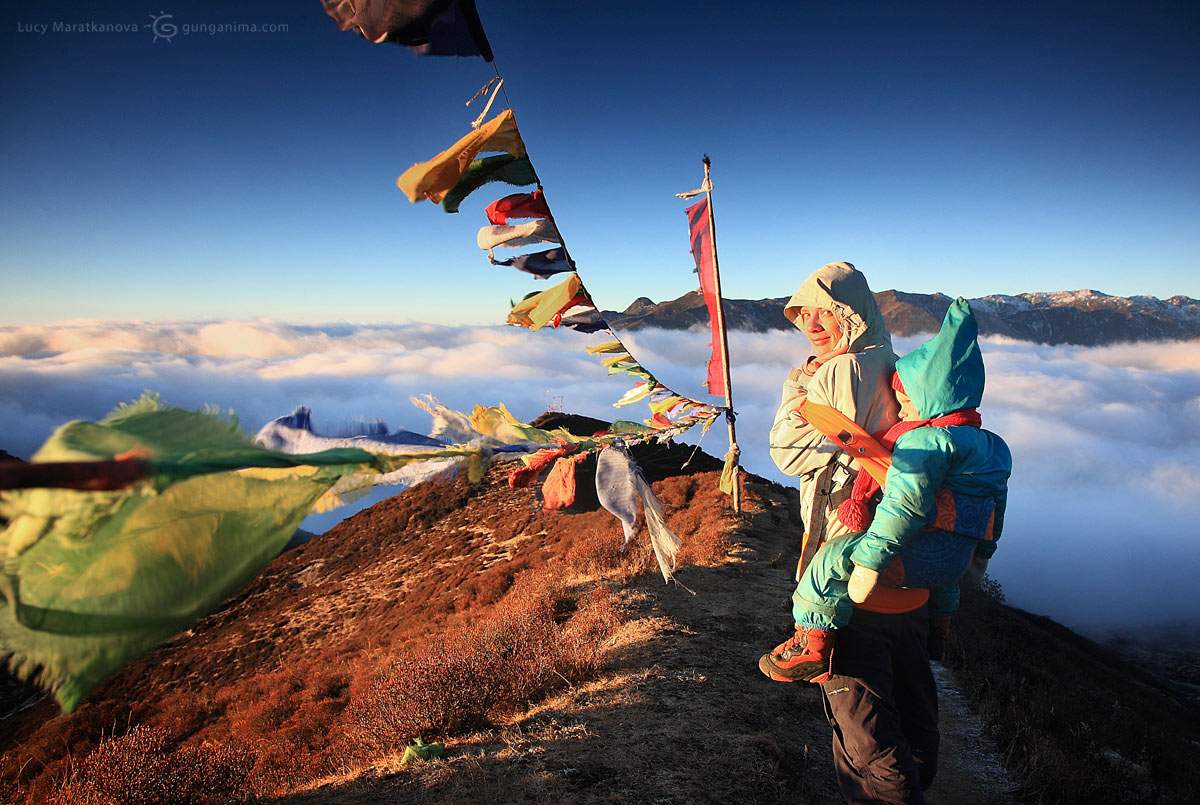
[{"left": 851, "top": 298, "right": 1013, "bottom": 570}]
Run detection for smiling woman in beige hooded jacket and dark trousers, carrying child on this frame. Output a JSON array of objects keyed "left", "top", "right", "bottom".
[{"left": 769, "top": 263, "right": 940, "bottom": 805}]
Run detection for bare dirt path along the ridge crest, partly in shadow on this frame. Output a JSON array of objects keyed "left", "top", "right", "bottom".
[{"left": 286, "top": 488, "right": 1012, "bottom": 805}]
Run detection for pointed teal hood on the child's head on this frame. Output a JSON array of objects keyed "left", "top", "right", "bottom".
[{"left": 896, "top": 296, "right": 984, "bottom": 419}]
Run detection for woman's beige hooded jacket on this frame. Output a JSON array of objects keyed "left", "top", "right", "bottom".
[{"left": 770, "top": 263, "right": 899, "bottom": 541}]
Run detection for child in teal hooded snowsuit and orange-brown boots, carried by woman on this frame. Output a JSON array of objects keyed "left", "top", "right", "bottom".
[{"left": 758, "top": 298, "right": 1013, "bottom": 681}]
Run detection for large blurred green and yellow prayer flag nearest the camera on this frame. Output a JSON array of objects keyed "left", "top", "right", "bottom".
[{"left": 0, "top": 396, "right": 432, "bottom": 711}]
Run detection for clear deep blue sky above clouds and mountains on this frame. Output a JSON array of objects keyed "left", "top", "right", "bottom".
[{"left": 0, "top": 0, "right": 1200, "bottom": 324}]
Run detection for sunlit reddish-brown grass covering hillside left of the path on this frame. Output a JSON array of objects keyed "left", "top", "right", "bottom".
[{"left": 0, "top": 465, "right": 727, "bottom": 803}]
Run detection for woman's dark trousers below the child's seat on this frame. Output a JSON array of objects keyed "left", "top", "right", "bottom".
[{"left": 821, "top": 607, "right": 940, "bottom": 805}]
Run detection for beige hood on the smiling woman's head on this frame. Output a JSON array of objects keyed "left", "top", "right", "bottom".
[{"left": 784, "top": 263, "right": 892, "bottom": 353}]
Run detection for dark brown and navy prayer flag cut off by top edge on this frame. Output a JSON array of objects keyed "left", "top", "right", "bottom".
[{"left": 323, "top": 0, "right": 492, "bottom": 61}]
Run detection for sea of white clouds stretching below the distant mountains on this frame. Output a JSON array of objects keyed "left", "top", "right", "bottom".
[{"left": 0, "top": 319, "right": 1200, "bottom": 632}]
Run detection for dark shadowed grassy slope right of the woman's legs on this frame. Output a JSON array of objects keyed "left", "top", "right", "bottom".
[{"left": 947, "top": 584, "right": 1200, "bottom": 804}]
